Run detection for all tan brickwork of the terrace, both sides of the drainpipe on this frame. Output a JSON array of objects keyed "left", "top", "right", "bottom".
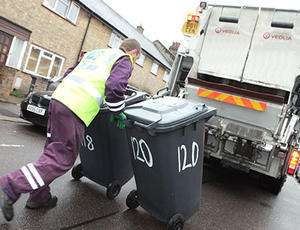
[{"left": 0, "top": 0, "right": 169, "bottom": 97}]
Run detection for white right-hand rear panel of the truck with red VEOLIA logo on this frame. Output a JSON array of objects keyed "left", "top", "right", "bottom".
[{"left": 243, "top": 8, "right": 300, "bottom": 91}]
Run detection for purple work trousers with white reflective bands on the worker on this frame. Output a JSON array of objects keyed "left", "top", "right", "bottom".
[{"left": 0, "top": 100, "right": 85, "bottom": 202}]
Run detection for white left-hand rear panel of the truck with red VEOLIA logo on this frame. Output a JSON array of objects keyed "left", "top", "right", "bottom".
[{"left": 198, "top": 6, "right": 259, "bottom": 81}]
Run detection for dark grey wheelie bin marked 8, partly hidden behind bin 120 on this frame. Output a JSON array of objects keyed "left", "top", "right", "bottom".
[{"left": 71, "top": 90, "right": 147, "bottom": 199}]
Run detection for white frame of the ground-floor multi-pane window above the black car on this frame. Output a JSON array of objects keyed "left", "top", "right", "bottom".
[{"left": 23, "top": 44, "right": 65, "bottom": 80}]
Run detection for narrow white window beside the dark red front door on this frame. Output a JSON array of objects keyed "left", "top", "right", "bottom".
[{"left": 6, "top": 37, "right": 27, "bottom": 69}]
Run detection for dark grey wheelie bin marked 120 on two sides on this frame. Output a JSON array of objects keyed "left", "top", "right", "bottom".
[{"left": 126, "top": 97, "right": 216, "bottom": 230}]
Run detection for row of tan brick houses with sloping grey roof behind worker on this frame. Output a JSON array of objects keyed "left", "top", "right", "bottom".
[{"left": 0, "top": 0, "right": 171, "bottom": 98}]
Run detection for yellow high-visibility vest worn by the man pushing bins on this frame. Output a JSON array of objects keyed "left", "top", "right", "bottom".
[{"left": 52, "top": 49, "right": 134, "bottom": 126}]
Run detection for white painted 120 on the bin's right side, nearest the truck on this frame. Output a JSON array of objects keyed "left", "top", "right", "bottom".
[{"left": 177, "top": 141, "right": 199, "bottom": 172}]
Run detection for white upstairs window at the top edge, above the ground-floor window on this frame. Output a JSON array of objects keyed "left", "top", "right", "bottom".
[{"left": 44, "top": 0, "right": 80, "bottom": 24}]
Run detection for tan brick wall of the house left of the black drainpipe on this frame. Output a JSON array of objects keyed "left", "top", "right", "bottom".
[{"left": 0, "top": 0, "right": 89, "bottom": 98}]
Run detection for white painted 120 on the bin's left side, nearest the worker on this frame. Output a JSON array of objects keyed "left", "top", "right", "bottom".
[{"left": 131, "top": 137, "right": 153, "bottom": 168}]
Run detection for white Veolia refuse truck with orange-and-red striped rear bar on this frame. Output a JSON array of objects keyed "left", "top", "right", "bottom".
[{"left": 165, "top": 2, "right": 300, "bottom": 194}]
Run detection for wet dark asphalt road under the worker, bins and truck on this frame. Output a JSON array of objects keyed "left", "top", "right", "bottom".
[{"left": 0, "top": 102, "right": 300, "bottom": 230}]
